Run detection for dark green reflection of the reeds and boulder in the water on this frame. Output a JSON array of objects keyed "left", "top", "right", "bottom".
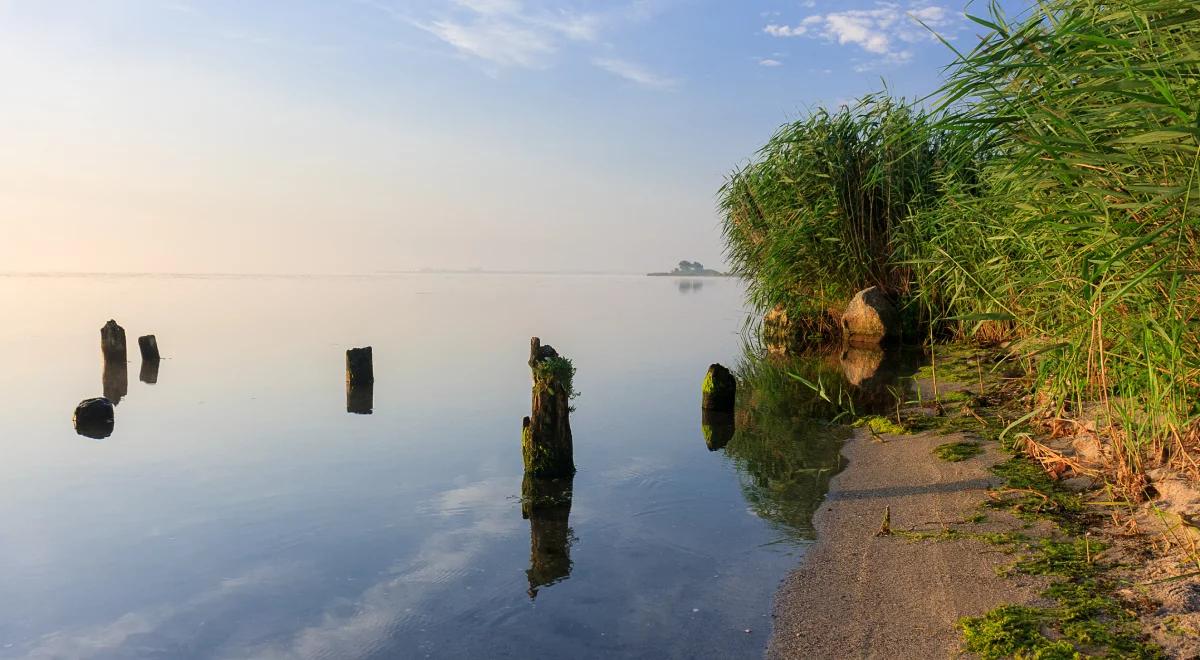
[{"left": 725, "top": 347, "right": 919, "bottom": 539}]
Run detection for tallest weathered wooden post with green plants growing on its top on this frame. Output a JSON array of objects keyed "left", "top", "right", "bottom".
[{"left": 521, "top": 337, "right": 575, "bottom": 479}]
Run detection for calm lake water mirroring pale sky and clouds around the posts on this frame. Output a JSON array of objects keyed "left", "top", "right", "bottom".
[{"left": 0, "top": 276, "right": 830, "bottom": 658}]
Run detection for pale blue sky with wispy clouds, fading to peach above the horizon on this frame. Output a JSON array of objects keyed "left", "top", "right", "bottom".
[{"left": 0, "top": 0, "right": 1021, "bottom": 272}]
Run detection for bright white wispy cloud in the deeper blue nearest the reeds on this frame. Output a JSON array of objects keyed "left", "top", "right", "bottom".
[{"left": 763, "top": 2, "right": 958, "bottom": 70}]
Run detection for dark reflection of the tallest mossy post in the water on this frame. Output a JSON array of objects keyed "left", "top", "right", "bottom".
[{"left": 521, "top": 474, "right": 575, "bottom": 599}]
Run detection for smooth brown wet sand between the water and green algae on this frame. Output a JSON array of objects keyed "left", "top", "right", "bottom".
[{"left": 767, "top": 430, "right": 1043, "bottom": 659}]
